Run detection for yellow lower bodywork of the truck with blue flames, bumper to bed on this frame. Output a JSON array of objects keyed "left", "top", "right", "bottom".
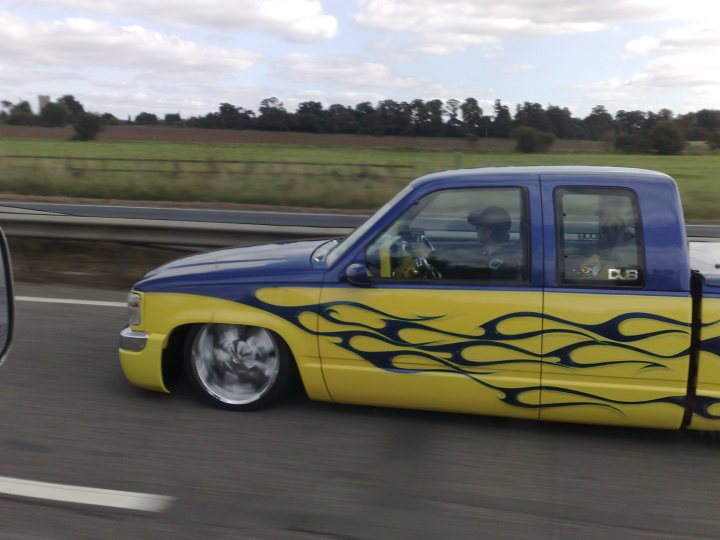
[{"left": 121, "top": 287, "right": 720, "bottom": 429}]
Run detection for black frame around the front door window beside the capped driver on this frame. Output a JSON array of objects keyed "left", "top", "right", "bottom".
[{"left": 362, "top": 185, "right": 532, "bottom": 287}]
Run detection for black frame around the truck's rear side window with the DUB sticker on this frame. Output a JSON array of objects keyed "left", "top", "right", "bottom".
[{"left": 553, "top": 185, "right": 647, "bottom": 290}]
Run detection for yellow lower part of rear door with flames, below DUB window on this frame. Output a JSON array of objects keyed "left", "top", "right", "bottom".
[{"left": 540, "top": 292, "right": 692, "bottom": 429}]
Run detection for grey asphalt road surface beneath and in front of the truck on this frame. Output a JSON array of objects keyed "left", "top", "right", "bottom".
[{"left": 0, "top": 284, "right": 720, "bottom": 540}]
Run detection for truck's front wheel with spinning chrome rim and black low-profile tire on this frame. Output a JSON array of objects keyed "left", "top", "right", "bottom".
[{"left": 185, "top": 324, "right": 291, "bottom": 411}]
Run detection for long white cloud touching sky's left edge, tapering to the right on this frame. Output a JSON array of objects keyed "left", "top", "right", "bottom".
[{"left": 0, "top": 11, "right": 260, "bottom": 77}]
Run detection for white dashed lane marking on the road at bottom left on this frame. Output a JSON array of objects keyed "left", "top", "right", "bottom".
[{"left": 0, "top": 476, "right": 175, "bottom": 512}]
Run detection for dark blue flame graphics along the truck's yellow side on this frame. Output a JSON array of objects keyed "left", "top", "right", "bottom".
[{"left": 252, "top": 295, "right": 708, "bottom": 419}]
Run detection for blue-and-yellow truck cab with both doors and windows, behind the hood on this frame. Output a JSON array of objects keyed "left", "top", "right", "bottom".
[{"left": 320, "top": 167, "right": 693, "bottom": 428}]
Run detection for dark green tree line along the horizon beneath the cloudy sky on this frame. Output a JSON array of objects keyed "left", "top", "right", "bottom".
[{"left": 0, "top": 95, "right": 720, "bottom": 154}]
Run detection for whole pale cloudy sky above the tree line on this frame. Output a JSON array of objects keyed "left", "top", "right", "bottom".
[{"left": 0, "top": 0, "right": 720, "bottom": 118}]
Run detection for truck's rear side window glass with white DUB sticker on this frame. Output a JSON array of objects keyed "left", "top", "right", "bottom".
[{"left": 555, "top": 188, "right": 645, "bottom": 287}]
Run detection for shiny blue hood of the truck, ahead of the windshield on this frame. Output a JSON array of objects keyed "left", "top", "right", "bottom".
[{"left": 134, "top": 240, "right": 328, "bottom": 291}]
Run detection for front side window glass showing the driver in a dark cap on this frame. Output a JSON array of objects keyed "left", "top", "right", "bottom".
[{"left": 365, "top": 188, "right": 528, "bottom": 282}]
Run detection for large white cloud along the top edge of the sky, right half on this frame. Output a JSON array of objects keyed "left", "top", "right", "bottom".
[{"left": 354, "top": 0, "right": 720, "bottom": 54}]
